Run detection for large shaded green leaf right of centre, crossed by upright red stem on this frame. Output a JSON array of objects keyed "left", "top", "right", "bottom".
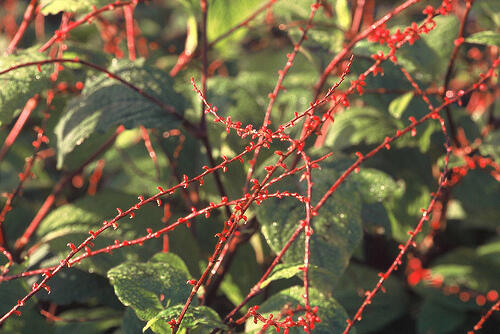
[{"left": 257, "top": 168, "right": 362, "bottom": 289}]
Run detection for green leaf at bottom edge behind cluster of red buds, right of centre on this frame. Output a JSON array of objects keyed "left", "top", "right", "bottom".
[{"left": 245, "top": 286, "right": 356, "bottom": 334}]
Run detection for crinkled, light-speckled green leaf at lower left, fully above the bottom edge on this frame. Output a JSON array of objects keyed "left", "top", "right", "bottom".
[{"left": 108, "top": 253, "right": 191, "bottom": 321}]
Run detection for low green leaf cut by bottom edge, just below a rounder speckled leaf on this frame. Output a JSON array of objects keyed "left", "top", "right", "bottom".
[{"left": 143, "top": 305, "right": 227, "bottom": 333}]
